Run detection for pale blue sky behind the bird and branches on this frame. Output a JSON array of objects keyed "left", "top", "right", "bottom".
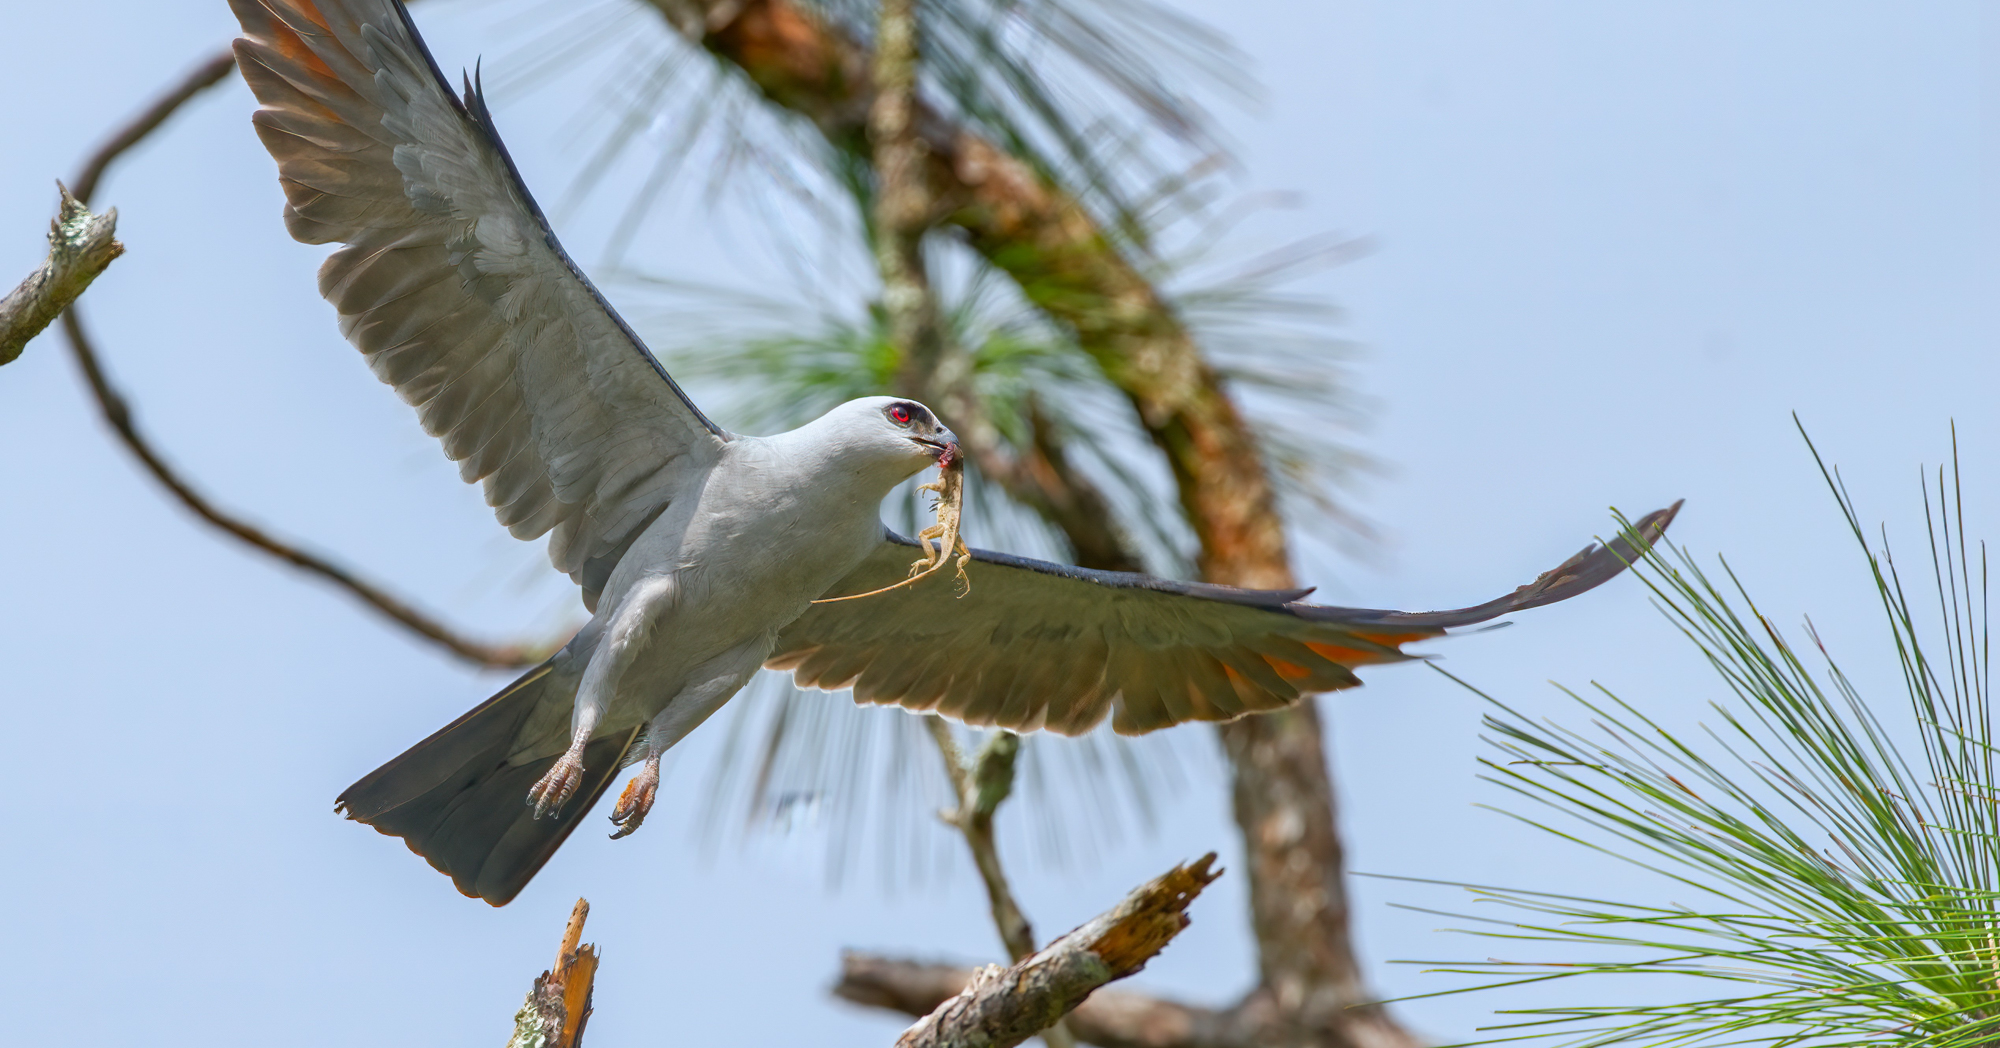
[{"left": 0, "top": 0, "right": 2000, "bottom": 1046}]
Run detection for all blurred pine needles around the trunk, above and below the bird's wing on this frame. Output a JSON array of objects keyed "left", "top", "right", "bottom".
[{"left": 462, "top": 0, "right": 1362, "bottom": 878}]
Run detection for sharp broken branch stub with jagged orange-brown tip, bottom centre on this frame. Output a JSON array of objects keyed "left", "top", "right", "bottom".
[{"left": 896, "top": 852, "right": 1222, "bottom": 1048}]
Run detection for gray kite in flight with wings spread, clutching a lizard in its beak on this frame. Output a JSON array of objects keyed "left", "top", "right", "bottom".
[{"left": 230, "top": 0, "right": 1678, "bottom": 906}]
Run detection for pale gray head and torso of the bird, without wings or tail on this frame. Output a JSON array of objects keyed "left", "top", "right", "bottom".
[{"left": 508, "top": 406, "right": 930, "bottom": 762}]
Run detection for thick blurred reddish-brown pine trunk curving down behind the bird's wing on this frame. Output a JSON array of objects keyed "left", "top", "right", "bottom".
[{"left": 646, "top": 0, "right": 1416, "bottom": 1048}]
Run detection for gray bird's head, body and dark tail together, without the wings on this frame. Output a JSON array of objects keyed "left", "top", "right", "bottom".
[{"left": 340, "top": 398, "right": 944, "bottom": 904}]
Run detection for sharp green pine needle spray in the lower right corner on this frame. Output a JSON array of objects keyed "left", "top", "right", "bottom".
[{"left": 1408, "top": 436, "right": 2000, "bottom": 1048}]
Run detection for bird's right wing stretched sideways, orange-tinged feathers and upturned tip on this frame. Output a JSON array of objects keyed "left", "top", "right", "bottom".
[{"left": 766, "top": 502, "right": 1680, "bottom": 734}]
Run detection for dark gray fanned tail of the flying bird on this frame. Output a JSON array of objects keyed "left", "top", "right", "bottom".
[{"left": 334, "top": 662, "right": 638, "bottom": 906}]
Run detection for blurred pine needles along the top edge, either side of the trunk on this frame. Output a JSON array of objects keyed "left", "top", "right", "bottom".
[{"left": 482, "top": 0, "right": 1254, "bottom": 258}]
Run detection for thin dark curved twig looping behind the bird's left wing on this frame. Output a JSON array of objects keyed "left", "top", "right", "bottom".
[{"left": 62, "top": 50, "right": 560, "bottom": 668}]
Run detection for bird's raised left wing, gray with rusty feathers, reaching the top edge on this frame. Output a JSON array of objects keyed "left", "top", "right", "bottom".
[{"left": 230, "top": 0, "right": 728, "bottom": 598}]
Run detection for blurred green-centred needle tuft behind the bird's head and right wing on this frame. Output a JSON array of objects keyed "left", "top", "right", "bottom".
[{"left": 640, "top": 256, "right": 1200, "bottom": 882}]
